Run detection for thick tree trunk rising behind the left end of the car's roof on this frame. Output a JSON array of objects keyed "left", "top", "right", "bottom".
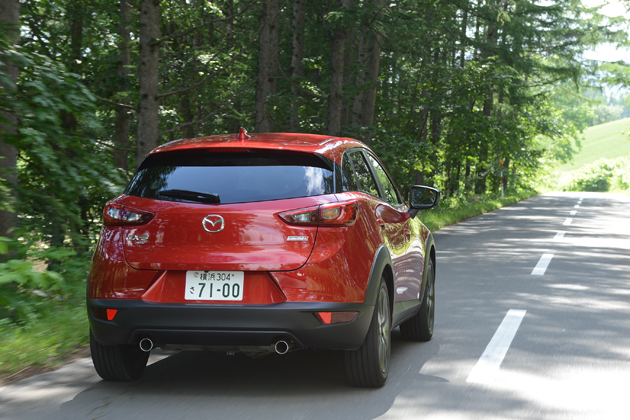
[{"left": 136, "top": 0, "right": 160, "bottom": 166}]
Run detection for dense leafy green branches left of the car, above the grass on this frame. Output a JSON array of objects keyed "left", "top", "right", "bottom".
[{"left": 3, "top": 46, "right": 124, "bottom": 250}]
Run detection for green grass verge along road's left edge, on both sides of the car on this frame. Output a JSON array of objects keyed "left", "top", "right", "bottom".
[{"left": 0, "top": 191, "right": 537, "bottom": 385}]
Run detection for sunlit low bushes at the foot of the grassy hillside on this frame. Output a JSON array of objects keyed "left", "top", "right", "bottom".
[{"left": 562, "top": 157, "right": 630, "bottom": 192}]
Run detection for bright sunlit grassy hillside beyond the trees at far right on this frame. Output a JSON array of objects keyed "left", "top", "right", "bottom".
[{"left": 554, "top": 118, "right": 630, "bottom": 179}]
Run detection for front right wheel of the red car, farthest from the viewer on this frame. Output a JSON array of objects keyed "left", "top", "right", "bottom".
[{"left": 400, "top": 259, "right": 435, "bottom": 341}]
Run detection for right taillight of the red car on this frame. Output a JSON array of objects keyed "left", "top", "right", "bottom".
[{"left": 278, "top": 201, "right": 358, "bottom": 226}]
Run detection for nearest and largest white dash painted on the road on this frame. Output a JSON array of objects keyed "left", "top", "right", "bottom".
[{"left": 466, "top": 309, "right": 527, "bottom": 384}]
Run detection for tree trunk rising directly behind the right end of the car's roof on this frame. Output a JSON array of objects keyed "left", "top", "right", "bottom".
[{"left": 328, "top": 0, "right": 351, "bottom": 136}]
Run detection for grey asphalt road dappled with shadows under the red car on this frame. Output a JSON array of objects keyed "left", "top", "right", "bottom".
[{"left": 0, "top": 193, "right": 630, "bottom": 420}]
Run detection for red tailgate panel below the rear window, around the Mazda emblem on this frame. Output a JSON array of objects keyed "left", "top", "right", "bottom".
[{"left": 117, "top": 196, "right": 330, "bottom": 271}]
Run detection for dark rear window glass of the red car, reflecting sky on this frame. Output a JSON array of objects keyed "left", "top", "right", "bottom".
[{"left": 125, "top": 150, "right": 334, "bottom": 204}]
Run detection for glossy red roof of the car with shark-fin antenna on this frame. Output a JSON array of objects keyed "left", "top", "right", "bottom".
[{"left": 149, "top": 131, "right": 367, "bottom": 163}]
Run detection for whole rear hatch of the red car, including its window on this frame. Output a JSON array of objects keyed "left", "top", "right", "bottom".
[{"left": 114, "top": 149, "right": 335, "bottom": 271}]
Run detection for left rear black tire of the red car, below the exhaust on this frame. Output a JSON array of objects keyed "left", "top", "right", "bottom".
[{"left": 90, "top": 331, "right": 149, "bottom": 382}]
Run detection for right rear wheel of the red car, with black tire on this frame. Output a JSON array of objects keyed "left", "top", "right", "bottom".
[{"left": 343, "top": 279, "right": 392, "bottom": 388}]
